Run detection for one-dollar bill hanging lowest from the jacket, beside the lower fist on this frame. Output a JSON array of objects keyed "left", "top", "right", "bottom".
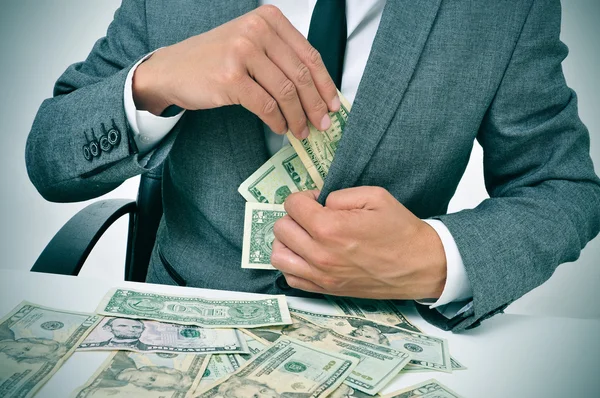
[{"left": 242, "top": 202, "right": 286, "bottom": 270}]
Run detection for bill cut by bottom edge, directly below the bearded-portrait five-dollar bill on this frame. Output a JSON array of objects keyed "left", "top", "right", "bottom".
[{"left": 71, "top": 351, "right": 210, "bottom": 398}]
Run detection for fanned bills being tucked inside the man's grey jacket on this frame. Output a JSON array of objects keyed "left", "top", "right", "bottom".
[{"left": 238, "top": 92, "right": 350, "bottom": 270}]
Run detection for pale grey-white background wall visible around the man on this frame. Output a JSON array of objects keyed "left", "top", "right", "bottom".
[{"left": 0, "top": 0, "right": 600, "bottom": 318}]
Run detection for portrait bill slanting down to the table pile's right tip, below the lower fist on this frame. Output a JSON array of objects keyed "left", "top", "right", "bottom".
[{"left": 290, "top": 309, "right": 452, "bottom": 373}]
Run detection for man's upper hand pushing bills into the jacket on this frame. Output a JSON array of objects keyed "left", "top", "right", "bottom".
[{"left": 133, "top": 6, "right": 340, "bottom": 138}]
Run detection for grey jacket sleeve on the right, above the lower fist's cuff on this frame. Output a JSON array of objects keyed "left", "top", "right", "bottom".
[{"left": 439, "top": 0, "right": 600, "bottom": 331}]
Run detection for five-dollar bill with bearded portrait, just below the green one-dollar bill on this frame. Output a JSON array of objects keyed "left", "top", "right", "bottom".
[{"left": 78, "top": 317, "right": 250, "bottom": 354}]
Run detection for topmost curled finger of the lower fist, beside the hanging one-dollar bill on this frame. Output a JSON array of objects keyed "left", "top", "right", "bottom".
[{"left": 283, "top": 191, "right": 327, "bottom": 237}]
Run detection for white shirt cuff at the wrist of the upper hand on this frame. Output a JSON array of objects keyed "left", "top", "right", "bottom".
[{"left": 123, "top": 51, "right": 184, "bottom": 154}]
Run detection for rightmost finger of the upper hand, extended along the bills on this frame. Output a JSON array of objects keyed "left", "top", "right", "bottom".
[{"left": 256, "top": 6, "right": 340, "bottom": 112}]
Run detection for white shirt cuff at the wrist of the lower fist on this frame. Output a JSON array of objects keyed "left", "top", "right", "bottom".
[{"left": 417, "top": 219, "right": 473, "bottom": 309}]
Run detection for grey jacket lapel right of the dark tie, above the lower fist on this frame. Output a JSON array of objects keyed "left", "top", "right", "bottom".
[{"left": 319, "top": 0, "right": 441, "bottom": 203}]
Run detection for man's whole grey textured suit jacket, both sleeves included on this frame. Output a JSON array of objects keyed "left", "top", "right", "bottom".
[{"left": 26, "top": 0, "right": 600, "bottom": 331}]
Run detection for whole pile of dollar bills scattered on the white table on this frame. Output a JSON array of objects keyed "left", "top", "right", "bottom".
[{"left": 0, "top": 289, "right": 466, "bottom": 398}]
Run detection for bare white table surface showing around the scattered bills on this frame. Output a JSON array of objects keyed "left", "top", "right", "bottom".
[{"left": 0, "top": 270, "right": 600, "bottom": 398}]
